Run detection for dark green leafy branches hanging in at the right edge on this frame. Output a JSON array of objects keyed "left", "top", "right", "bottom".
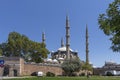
[{"left": 98, "top": 0, "right": 120, "bottom": 52}]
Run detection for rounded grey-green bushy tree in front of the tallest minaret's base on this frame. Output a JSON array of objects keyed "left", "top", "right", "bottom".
[{"left": 62, "top": 59, "right": 81, "bottom": 76}]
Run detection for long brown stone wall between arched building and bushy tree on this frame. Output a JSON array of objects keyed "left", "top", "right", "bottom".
[{"left": 22, "top": 64, "right": 63, "bottom": 76}]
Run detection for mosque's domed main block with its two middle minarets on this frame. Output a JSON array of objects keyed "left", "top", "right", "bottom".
[{"left": 51, "top": 16, "right": 78, "bottom": 63}]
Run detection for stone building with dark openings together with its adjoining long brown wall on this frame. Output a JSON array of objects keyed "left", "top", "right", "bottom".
[{"left": 0, "top": 57, "right": 63, "bottom": 77}]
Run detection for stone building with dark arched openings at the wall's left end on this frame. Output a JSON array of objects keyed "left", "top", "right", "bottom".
[{"left": 1, "top": 57, "right": 24, "bottom": 76}]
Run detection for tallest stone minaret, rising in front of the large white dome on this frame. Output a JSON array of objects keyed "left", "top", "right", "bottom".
[{"left": 66, "top": 16, "right": 70, "bottom": 59}]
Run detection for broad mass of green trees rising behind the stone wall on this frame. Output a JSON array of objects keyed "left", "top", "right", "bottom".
[{"left": 0, "top": 32, "right": 49, "bottom": 62}]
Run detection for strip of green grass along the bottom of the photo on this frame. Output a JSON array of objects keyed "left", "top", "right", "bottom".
[{"left": 3, "top": 76, "right": 120, "bottom": 80}]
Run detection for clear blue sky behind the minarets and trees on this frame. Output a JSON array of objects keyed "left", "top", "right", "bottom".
[{"left": 0, "top": 0, "right": 120, "bottom": 66}]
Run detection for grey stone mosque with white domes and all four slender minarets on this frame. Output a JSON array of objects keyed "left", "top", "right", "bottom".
[{"left": 42, "top": 16, "right": 89, "bottom": 64}]
